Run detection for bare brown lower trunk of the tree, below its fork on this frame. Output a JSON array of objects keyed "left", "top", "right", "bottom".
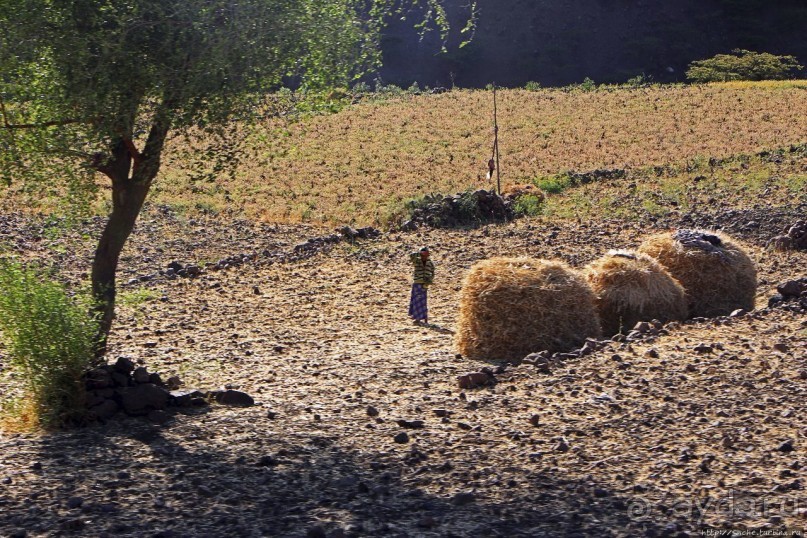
[{"left": 92, "top": 180, "right": 151, "bottom": 359}]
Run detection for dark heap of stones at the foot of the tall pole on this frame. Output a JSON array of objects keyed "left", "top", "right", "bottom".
[{"left": 401, "top": 189, "right": 515, "bottom": 231}]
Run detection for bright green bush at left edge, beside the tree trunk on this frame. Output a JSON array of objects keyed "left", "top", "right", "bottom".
[{"left": 0, "top": 260, "right": 98, "bottom": 428}]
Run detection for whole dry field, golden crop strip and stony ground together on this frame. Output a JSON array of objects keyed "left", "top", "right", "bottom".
[{"left": 0, "top": 80, "right": 807, "bottom": 538}]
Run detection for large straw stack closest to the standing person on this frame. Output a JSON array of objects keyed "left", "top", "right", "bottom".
[{"left": 455, "top": 258, "right": 600, "bottom": 361}]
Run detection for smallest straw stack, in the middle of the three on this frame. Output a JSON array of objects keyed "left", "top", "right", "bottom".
[{"left": 583, "top": 250, "right": 687, "bottom": 336}]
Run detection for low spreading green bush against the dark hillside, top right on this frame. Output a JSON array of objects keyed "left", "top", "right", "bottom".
[{"left": 686, "top": 49, "right": 802, "bottom": 82}]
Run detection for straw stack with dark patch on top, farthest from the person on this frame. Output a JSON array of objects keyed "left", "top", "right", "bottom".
[{"left": 638, "top": 230, "right": 757, "bottom": 317}]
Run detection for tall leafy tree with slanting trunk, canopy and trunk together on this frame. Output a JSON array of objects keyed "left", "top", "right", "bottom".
[{"left": 0, "top": 0, "right": 470, "bottom": 356}]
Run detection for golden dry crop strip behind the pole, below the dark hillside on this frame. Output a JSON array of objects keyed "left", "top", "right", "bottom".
[{"left": 155, "top": 81, "right": 807, "bottom": 223}]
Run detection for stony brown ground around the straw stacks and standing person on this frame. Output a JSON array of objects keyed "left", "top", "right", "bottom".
[{"left": 0, "top": 202, "right": 807, "bottom": 537}]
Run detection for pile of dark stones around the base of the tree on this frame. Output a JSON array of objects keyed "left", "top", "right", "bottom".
[{"left": 84, "top": 357, "right": 255, "bottom": 423}]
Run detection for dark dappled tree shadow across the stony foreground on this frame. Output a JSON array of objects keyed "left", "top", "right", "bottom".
[{"left": 0, "top": 417, "right": 680, "bottom": 537}]
